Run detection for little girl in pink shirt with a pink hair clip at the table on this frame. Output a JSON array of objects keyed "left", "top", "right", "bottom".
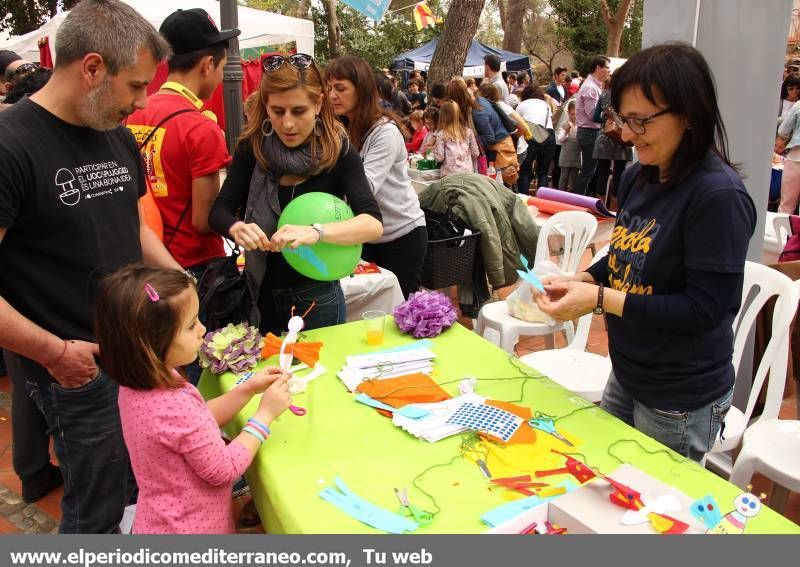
[{"left": 95, "top": 265, "right": 291, "bottom": 534}]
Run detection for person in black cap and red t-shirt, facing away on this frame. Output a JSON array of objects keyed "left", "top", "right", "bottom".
[{"left": 127, "top": 8, "right": 240, "bottom": 284}]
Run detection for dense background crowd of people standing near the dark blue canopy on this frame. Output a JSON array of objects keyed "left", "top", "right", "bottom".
[{"left": 376, "top": 54, "right": 633, "bottom": 205}]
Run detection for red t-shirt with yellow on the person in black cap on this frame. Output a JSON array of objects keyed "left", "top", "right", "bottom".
[{"left": 127, "top": 93, "right": 231, "bottom": 268}]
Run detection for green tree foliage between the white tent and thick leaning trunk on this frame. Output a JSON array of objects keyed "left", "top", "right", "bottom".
[{"left": 311, "top": 0, "right": 441, "bottom": 69}]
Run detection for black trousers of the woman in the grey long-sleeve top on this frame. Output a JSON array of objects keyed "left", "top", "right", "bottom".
[{"left": 361, "top": 226, "right": 428, "bottom": 299}]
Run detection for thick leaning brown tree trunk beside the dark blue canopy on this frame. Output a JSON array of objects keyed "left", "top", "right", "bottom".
[{"left": 428, "top": 0, "right": 485, "bottom": 84}]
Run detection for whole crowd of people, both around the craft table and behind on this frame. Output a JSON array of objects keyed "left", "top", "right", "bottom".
[{"left": 0, "top": 0, "right": 764, "bottom": 533}]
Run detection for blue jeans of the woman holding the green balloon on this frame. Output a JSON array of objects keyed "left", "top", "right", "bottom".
[{"left": 258, "top": 280, "right": 347, "bottom": 336}]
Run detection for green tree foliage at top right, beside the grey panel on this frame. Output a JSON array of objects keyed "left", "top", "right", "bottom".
[{"left": 548, "top": 0, "right": 644, "bottom": 71}]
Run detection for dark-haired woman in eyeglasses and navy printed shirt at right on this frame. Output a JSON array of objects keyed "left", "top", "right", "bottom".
[{"left": 537, "top": 43, "right": 756, "bottom": 461}]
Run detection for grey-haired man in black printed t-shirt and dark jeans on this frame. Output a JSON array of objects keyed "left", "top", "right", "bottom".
[{"left": 0, "top": 0, "right": 180, "bottom": 533}]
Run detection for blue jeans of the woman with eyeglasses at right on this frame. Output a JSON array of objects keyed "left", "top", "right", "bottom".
[{"left": 600, "top": 372, "right": 733, "bottom": 462}]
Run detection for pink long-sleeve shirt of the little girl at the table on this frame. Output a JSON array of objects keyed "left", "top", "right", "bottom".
[{"left": 119, "top": 382, "right": 252, "bottom": 534}]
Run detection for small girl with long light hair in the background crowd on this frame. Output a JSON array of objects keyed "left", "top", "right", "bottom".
[{"left": 433, "top": 100, "right": 480, "bottom": 177}]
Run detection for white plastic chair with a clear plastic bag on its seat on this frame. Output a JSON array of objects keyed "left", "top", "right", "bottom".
[{"left": 475, "top": 211, "right": 597, "bottom": 354}]
